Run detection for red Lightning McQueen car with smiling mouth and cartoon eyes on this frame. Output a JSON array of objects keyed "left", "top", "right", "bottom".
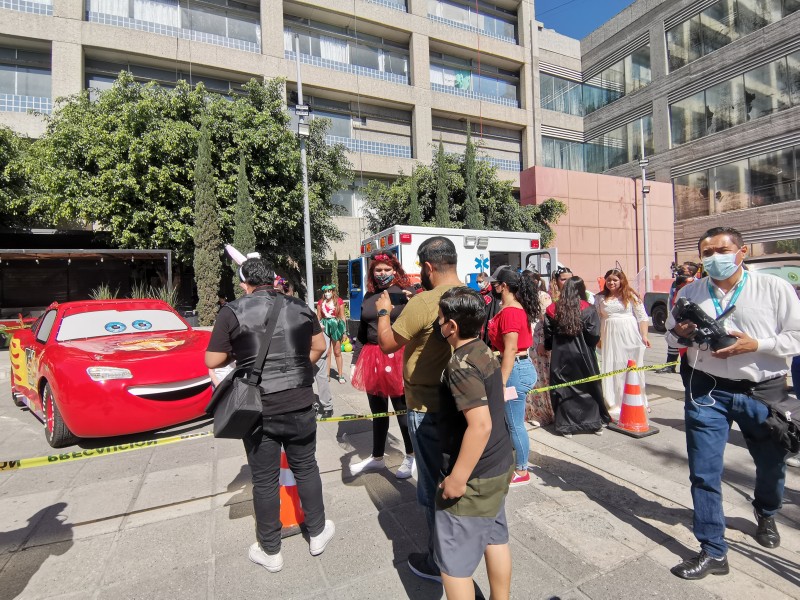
[{"left": 9, "top": 300, "right": 211, "bottom": 448}]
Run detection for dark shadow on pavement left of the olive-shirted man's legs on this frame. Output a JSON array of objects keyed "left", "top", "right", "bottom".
[{"left": 336, "top": 421, "right": 443, "bottom": 600}]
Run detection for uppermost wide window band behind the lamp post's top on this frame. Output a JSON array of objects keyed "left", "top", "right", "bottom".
[{"left": 283, "top": 17, "right": 409, "bottom": 84}]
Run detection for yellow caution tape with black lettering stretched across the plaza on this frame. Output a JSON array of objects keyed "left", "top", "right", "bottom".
[{"left": 0, "top": 361, "right": 678, "bottom": 471}]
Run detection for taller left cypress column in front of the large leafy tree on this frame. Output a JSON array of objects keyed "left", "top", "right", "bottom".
[{"left": 194, "top": 123, "right": 222, "bottom": 325}]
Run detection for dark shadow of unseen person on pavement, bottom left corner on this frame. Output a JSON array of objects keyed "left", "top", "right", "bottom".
[{"left": 0, "top": 502, "right": 73, "bottom": 599}]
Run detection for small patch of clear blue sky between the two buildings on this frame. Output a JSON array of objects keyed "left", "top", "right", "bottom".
[{"left": 534, "top": 0, "right": 634, "bottom": 39}]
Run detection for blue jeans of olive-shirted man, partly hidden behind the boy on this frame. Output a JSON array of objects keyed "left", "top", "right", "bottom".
[{"left": 407, "top": 410, "right": 442, "bottom": 557}]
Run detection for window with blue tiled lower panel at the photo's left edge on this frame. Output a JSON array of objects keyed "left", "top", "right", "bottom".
[{"left": 0, "top": 47, "right": 52, "bottom": 113}]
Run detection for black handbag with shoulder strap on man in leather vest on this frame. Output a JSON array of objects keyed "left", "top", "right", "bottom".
[{"left": 206, "top": 294, "right": 283, "bottom": 440}]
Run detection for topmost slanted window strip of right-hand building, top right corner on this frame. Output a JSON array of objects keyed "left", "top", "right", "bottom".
[{"left": 666, "top": 0, "right": 800, "bottom": 71}]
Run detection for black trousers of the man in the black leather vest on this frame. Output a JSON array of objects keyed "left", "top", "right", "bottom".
[{"left": 244, "top": 406, "right": 325, "bottom": 554}]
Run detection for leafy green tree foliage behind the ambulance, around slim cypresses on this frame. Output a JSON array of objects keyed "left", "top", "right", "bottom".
[{"left": 364, "top": 149, "right": 567, "bottom": 246}]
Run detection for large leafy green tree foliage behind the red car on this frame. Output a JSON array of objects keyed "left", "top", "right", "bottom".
[{"left": 18, "top": 72, "right": 350, "bottom": 272}]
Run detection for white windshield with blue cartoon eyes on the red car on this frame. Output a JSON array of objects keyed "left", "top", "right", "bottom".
[{"left": 56, "top": 310, "right": 187, "bottom": 342}]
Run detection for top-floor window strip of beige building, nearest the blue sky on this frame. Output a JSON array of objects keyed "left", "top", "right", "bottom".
[{"left": 428, "top": 0, "right": 517, "bottom": 44}]
